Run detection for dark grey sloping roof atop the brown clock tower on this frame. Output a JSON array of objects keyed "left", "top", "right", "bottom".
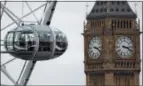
[{"left": 86, "top": 0, "right": 137, "bottom": 20}]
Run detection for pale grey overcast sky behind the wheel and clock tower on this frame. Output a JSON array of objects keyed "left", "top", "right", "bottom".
[{"left": 1, "top": 0, "right": 142, "bottom": 85}]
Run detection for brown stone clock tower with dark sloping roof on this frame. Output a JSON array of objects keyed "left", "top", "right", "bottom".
[{"left": 83, "top": 1, "right": 140, "bottom": 86}]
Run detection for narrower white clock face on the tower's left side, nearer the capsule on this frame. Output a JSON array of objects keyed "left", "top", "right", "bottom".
[{"left": 88, "top": 36, "right": 102, "bottom": 59}]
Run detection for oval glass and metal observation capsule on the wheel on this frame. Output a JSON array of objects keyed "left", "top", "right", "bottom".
[{"left": 4, "top": 25, "right": 68, "bottom": 61}]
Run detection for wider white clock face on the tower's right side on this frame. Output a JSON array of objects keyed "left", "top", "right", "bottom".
[{"left": 116, "top": 36, "right": 134, "bottom": 58}]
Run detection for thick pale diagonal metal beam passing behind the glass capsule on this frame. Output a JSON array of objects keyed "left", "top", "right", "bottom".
[{"left": 16, "top": 0, "right": 57, "bottom": 86}]
